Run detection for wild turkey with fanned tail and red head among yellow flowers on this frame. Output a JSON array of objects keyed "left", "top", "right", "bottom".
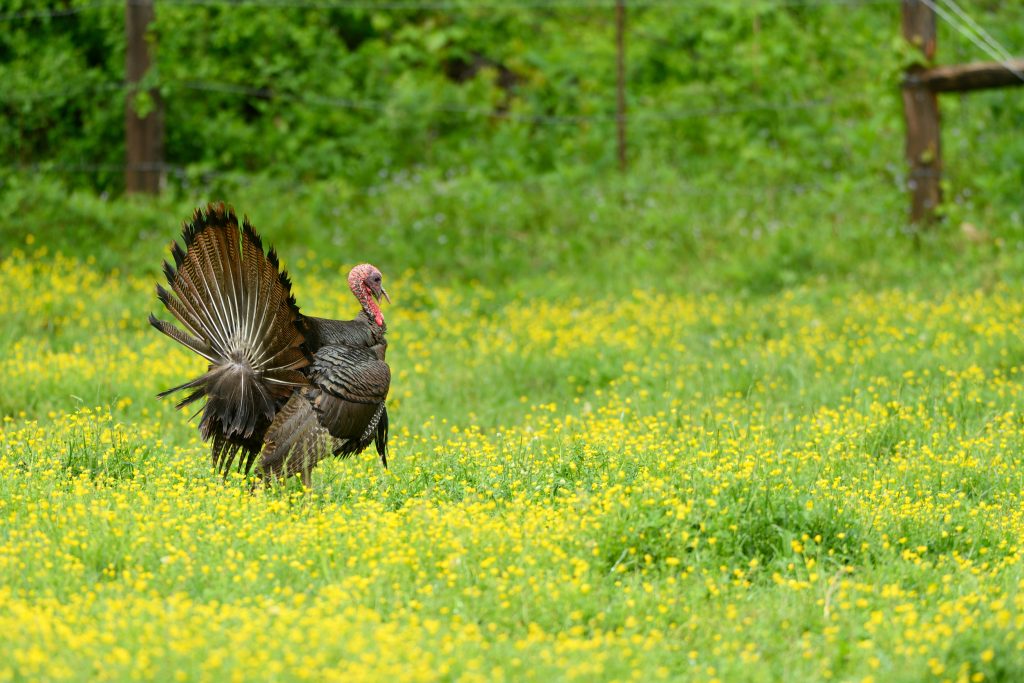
[{"left": 150, "top": 204, "right": 391, "bottom": 485}]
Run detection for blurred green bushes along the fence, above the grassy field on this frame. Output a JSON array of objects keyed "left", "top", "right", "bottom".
[{"left": 0, "top": 0, "right": 1024, "bottom": 189}]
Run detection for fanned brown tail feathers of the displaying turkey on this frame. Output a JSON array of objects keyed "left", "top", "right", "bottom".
[{"left": 150, "top": 204, "right": 309, "bottom": 454}]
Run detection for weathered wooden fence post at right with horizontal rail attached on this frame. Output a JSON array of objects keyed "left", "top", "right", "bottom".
[{"left": 902, "top": 0, "right": 942, "bottom": 223}]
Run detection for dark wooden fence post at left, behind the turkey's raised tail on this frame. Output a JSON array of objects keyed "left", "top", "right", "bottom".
[{"left": 125, "top": 0, "right": 164, "bottom": 195}]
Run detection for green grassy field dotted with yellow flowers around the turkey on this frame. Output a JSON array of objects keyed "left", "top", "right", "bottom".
[{"left": 0, "top": 172, "right": 1024, "bottom": 682}]
